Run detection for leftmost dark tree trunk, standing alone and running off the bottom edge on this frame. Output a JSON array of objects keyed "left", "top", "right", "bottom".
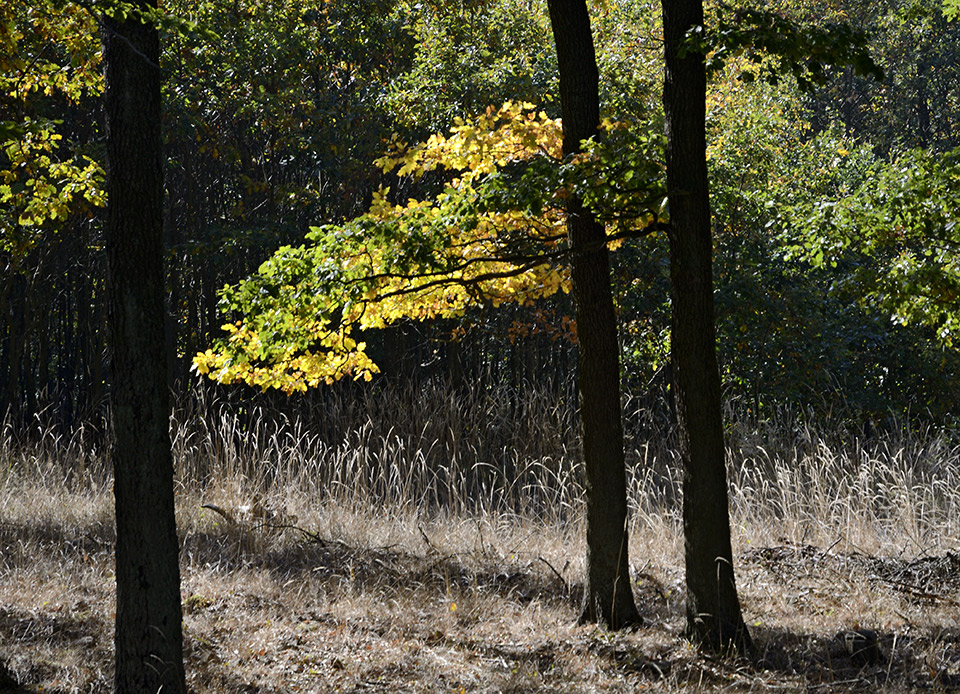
[{"left": 102, "top": 4, "right": 186, "bottom": 694}]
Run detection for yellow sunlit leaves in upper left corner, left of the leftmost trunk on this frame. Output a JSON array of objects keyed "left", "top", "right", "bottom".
[{"left": 0, "top": 0, "right": 105, "bottom": 267}]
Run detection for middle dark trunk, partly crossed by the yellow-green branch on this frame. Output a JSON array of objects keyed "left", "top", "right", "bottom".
[{"left": 549, "top": 0, "right": 640, "bottom": 629}]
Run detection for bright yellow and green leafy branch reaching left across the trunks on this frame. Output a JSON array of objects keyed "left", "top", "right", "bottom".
[{"left": 194, "top": 102, "right": 663, "bottom": 392}]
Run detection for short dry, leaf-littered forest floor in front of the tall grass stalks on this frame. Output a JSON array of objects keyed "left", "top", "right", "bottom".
[{"left": 0, "top": 481, "right": 960, "bottom": 694}]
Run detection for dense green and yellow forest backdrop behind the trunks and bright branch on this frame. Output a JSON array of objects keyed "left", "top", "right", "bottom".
[{"left": 0, "top": 2, "right": 960, "bottom": 428}]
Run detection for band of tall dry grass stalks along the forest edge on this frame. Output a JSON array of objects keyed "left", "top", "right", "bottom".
[{"left": 0, "top": 382, "right": 960, "bottom": 554}]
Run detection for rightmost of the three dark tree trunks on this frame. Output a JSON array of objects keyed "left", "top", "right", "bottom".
[{"left": 662, "top": 0, "right": 750, "bottom": 650}]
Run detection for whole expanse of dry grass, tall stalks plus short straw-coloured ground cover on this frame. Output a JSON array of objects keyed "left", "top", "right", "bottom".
[{"left": 0, "top": 387, "right": 960, "bottom": 694}]
